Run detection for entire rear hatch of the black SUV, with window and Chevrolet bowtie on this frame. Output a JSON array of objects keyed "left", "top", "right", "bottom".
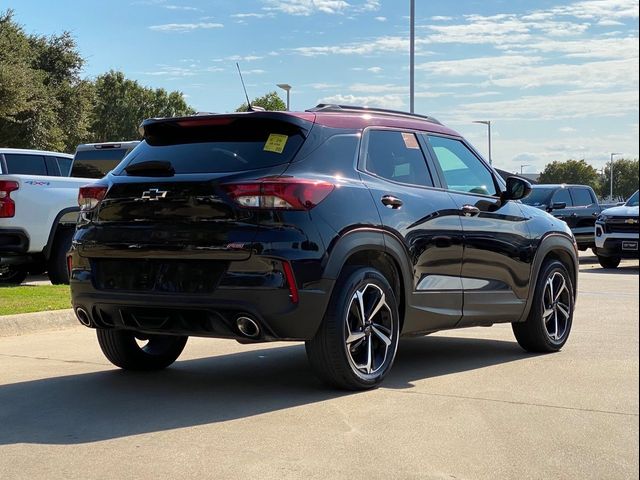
[{"left": 78, "top": 112, "right": 313, "bottom": 272}]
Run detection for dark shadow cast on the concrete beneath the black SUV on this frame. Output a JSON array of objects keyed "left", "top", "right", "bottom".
[{"left": 0, "top": 336, "right": 530, "bottom": 445}]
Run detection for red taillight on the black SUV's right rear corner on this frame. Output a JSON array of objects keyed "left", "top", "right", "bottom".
[{"left": 224, "top": 178, "right": 335, "bottom": 210}]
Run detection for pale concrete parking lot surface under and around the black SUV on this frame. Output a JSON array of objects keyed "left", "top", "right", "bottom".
[{"left": 0, "top": 255, "right": 639, "bottom": 480}]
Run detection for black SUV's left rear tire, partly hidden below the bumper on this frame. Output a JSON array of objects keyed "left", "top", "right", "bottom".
[{"left": 96, "top": 328, "right": 189, "bottom": 371}]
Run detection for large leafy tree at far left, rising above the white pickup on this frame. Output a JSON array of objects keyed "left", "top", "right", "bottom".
[{"left": 0, "top": 10, "right": 90, "bottom": 150}]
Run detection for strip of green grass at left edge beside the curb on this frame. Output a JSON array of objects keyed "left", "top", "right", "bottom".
[{"left": 0, "top": 285, "right": 71, "bottom": 315}]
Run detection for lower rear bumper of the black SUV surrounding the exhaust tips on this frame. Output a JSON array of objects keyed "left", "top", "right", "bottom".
[{"left": 71, "top": 279, "right": 333, "bottom": 341}]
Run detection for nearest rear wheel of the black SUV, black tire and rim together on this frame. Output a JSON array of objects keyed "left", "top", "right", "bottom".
[{"left": 305, "top": 268, "right": 400, "bottom": 390}]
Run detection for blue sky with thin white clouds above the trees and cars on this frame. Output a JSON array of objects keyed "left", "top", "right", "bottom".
[{"left": 5, "top": 0, "right": 638, "bottom": 172}]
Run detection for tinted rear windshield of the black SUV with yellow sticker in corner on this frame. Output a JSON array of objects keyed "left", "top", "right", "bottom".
[{"left": 114, "top": 118, "right": 304, "bottom": 175}]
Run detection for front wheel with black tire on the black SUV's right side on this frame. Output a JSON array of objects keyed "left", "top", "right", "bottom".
[{"left": 511, "top": 260, "right": 575, "bottom": 353}]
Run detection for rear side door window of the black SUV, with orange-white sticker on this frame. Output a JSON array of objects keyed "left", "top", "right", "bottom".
[{"left": 365, "top": 130, "right": 433, "bottom": 187}]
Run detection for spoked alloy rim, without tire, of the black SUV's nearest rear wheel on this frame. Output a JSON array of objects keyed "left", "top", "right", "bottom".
[{"left": 345, "top": 283, "right": 395, "bottom": 375}]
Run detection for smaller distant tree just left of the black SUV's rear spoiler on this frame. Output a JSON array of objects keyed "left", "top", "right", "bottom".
[{"left": 91, "top": 70, "right": 194, "bottom": 142}]
